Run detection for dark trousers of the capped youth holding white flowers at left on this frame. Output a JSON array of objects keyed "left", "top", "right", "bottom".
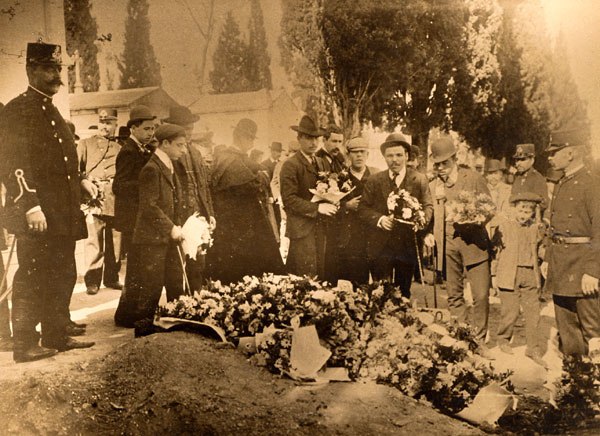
[{"left": 115, "top": 243, "right": 184, "bottom": 327}]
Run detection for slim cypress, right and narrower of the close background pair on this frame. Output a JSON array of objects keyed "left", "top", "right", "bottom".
[{"left": 248, "top": 0, "right": 273, "bottom": 90}]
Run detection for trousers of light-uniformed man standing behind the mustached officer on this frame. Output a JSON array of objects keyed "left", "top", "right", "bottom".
[{"left": 84, "top": 216, "right": 121, "bottom": 287}]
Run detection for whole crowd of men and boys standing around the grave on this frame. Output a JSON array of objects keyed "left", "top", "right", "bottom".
[{"left": 0, "top": 43, "right": 600, "bottom": 364}]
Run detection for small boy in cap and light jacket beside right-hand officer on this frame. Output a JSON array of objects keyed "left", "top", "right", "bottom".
[{"left": 493, "top": 192, "right": 546, "bottom": 367}]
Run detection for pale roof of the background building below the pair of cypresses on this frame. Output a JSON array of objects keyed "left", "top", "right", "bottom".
[{"left": 189, "top": 89, "right": 285, "bottom": 114}]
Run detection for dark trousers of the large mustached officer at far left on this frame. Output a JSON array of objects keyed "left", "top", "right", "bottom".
[{"left": 12, "top": 236, "right": 77, "bottom": 352}]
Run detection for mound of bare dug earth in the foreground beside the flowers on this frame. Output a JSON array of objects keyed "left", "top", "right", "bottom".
[{"left": 0, "top": 332, "right": 481, "bottom": 435}]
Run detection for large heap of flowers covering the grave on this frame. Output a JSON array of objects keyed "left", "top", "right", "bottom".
[{"left": 159, "top": 274, "right": 505, "bottom": 413}]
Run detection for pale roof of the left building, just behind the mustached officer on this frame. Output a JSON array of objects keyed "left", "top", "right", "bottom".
[{"left": 69, "top": 86, "right": 166, "bottom": 111}]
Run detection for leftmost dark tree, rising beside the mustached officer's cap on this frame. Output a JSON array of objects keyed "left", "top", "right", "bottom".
[{"left": 64, "top": 0, "right": 100, "bottom": 92}]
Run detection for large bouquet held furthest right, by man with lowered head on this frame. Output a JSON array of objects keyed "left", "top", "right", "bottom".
[{"left": 446, "top": 191, "right": 496, "bottom": 224}]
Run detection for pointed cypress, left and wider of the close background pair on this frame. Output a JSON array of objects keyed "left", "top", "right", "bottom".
[{"left": 209, "top": 12, "right": 250, "bottom": 94}]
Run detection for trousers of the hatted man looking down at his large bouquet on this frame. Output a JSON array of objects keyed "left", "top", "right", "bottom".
[{"left": 446, "top": 247, "right": 491, "bottom": 340}]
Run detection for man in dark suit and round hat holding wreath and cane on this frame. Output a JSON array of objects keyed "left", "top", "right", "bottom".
[{"left": 359, "top": 133, "right": 433, "bottom": 298}]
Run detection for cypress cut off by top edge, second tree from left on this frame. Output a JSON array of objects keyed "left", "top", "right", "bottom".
[{"left": 119, "top": 0, "right": 162, "bottom": 89}]
